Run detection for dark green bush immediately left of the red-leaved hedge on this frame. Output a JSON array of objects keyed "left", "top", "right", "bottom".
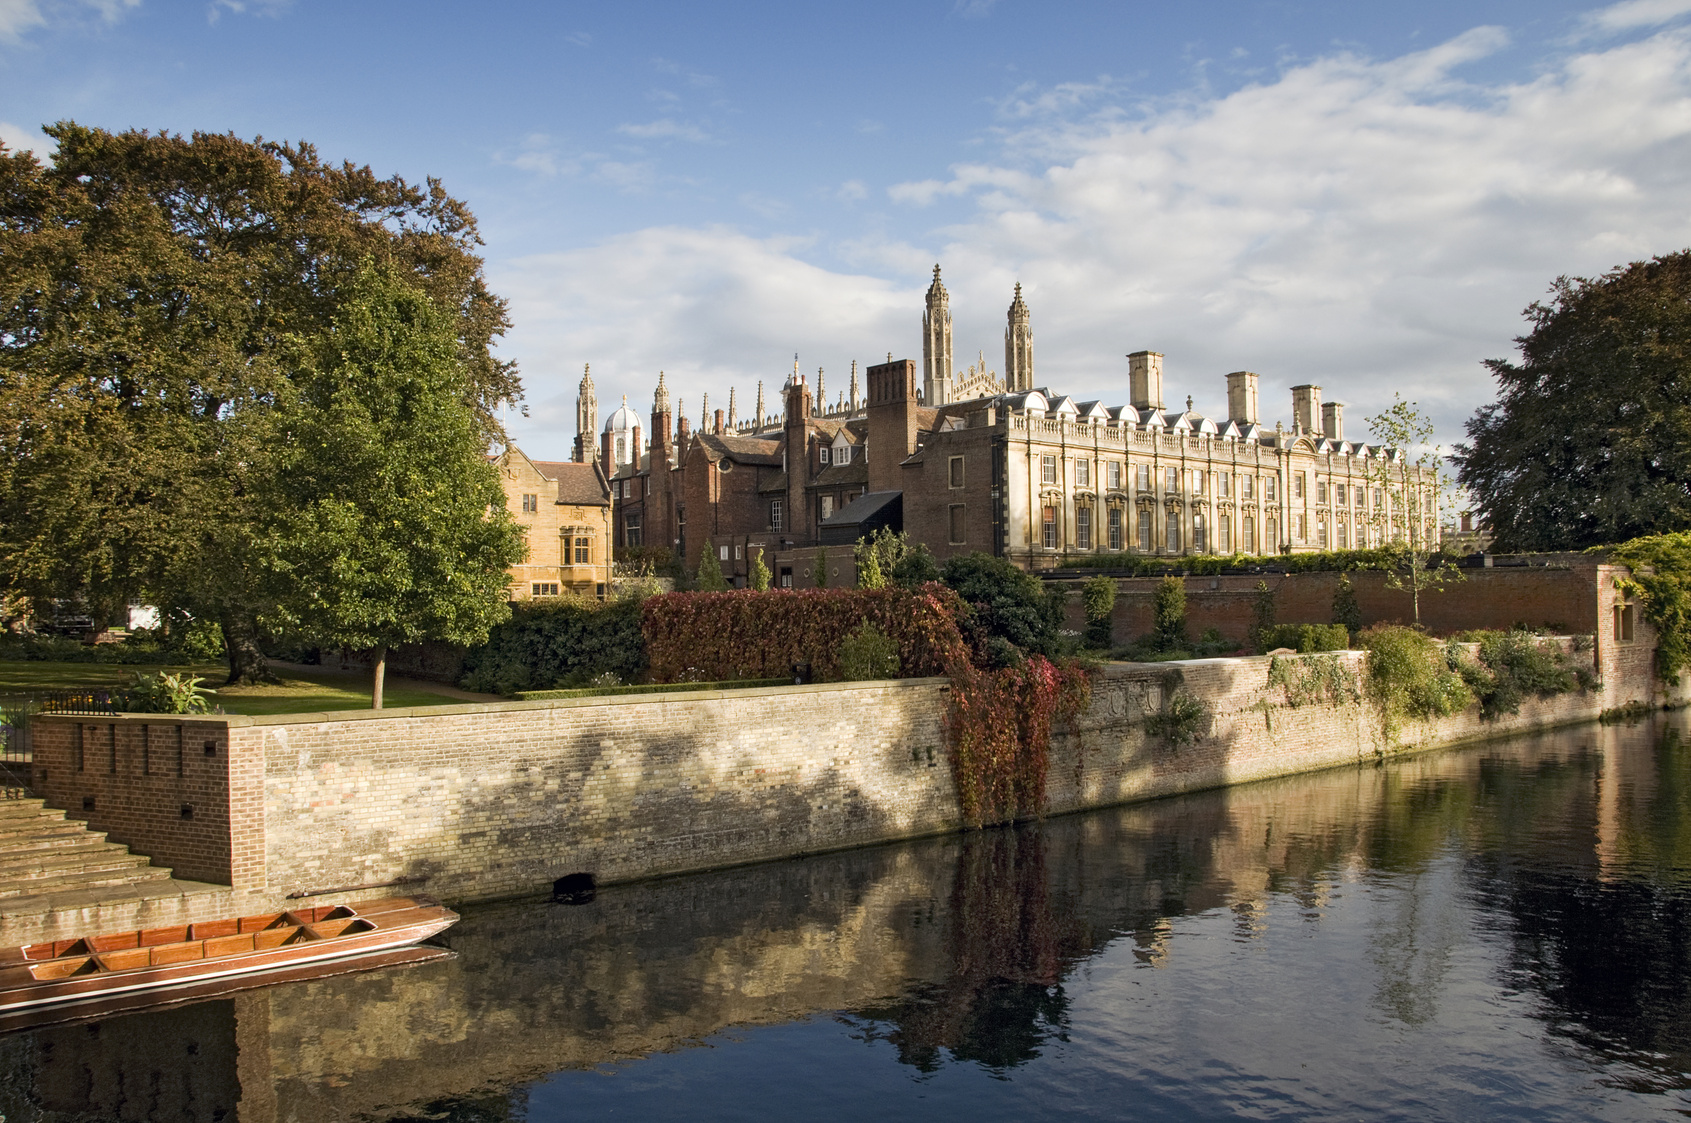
[{"left": 460, "top": 594, "right": 645, "bottom": 695}]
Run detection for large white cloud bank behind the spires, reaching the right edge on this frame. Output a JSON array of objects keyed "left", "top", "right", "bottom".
[{"left": 494, "top": 21, "right": 1691, "bottom": 452}]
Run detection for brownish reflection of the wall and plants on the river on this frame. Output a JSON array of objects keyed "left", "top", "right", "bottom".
[{"left": 0, "top": 715, "right": 1691, "bottom": 1123}]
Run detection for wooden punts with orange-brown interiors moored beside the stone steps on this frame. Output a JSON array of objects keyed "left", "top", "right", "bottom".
[{"left": 0, "top": 896, "right": 458, "bottom": 1030}]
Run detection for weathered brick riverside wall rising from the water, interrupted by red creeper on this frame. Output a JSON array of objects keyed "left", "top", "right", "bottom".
[{"left": 19, "top": 602, "right": 1669, "bottom": 933}]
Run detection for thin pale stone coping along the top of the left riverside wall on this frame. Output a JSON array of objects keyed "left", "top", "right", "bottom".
[{"left": 34, "top": 675, "right": 950, "bottom": 729}]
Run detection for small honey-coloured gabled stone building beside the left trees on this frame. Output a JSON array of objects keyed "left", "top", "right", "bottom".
[{"left": 497, "top": 446, "right": 612, "bottom": 600}]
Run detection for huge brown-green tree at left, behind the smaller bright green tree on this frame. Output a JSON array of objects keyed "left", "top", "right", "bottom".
[{"left": 0, "top": 123, "right": 521, "bottom": 682}]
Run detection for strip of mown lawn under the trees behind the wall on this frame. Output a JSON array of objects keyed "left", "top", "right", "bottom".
[{"left": 0, "top": 660, "right": 462, "bottom": 715}]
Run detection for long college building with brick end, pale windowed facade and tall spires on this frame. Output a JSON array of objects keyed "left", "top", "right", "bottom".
[{"left": 601, "top": 267, "right": 1439, "bottom": 583}]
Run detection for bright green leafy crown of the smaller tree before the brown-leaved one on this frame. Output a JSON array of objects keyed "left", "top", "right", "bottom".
[{"left": 269, "top": 266, "right": 523, "bottom": 676}]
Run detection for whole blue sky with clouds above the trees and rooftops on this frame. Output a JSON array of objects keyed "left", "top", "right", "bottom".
[{"left": 0, "top": 0, "right": 1691, "bottom": 458}]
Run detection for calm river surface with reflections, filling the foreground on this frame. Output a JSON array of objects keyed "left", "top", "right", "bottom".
[{"left": 0, "top": 714, "right": 1691, "bottom": 1123}]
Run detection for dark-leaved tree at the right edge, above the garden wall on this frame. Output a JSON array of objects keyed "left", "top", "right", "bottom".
[{"left": 1454, "top": 250, "right": 1691, "bottom": 550}]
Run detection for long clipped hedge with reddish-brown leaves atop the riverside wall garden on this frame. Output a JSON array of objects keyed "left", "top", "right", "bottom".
[{"left": 641, "top": 583, "right": 969, "bottom": 682}]
